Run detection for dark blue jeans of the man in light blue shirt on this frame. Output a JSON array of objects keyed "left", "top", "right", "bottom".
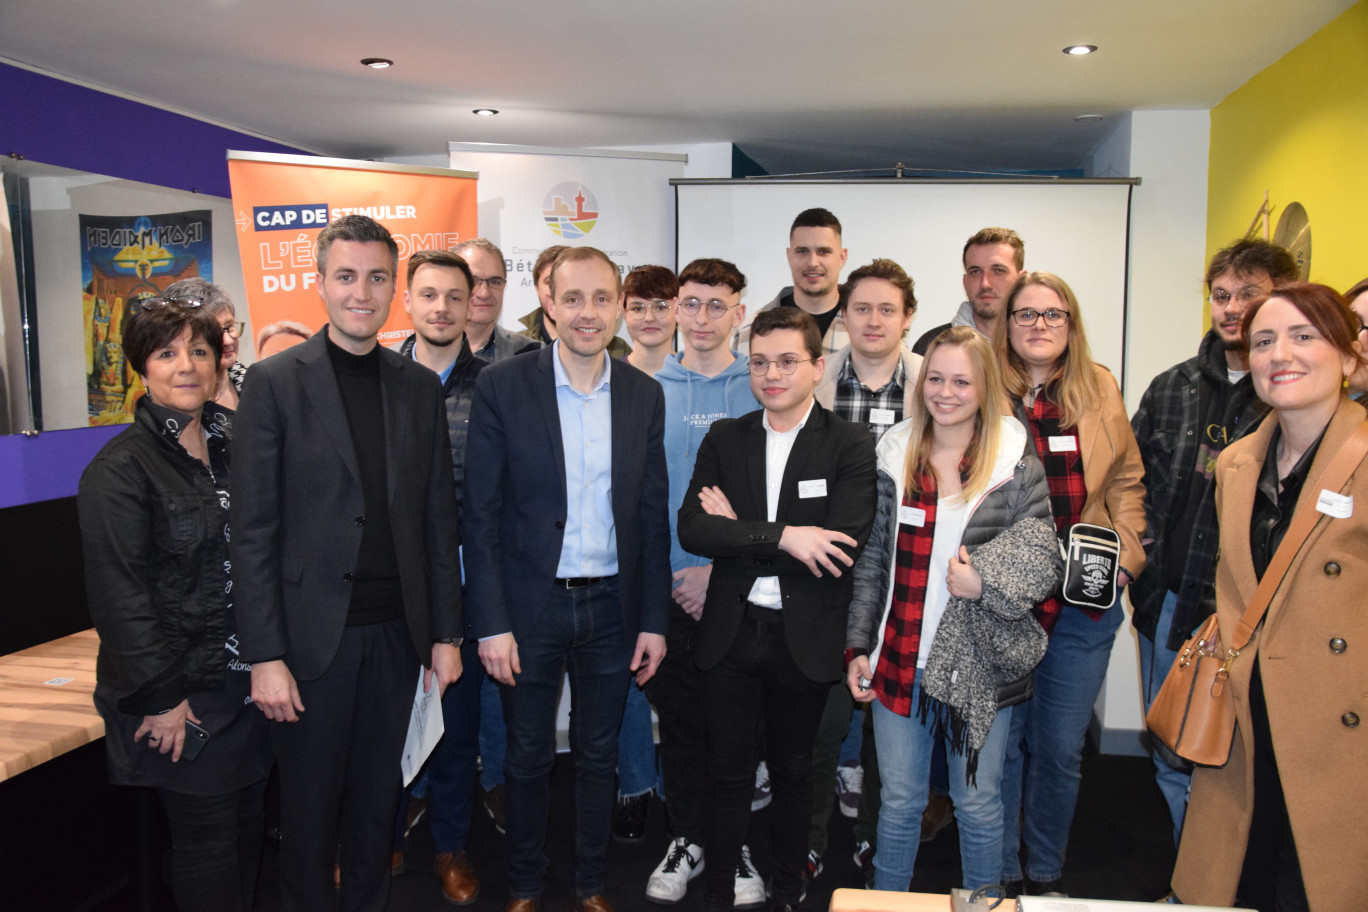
[{"left": 499, "top": 577, "right": 635, "bottom": 900}]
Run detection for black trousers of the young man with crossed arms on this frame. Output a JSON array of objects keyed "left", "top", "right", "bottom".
[{"left": 700, "top": 606, "right": 830, "bottom": 912}]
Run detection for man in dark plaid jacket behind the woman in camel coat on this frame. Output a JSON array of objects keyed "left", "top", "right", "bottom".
[{"left": 1130, "top": 241, "right": 1297, "bottom": 845}]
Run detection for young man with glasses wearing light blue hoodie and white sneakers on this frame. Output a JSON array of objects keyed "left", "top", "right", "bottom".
[{"left": 646, "top": 258, "right": 765, "bottom": 905}]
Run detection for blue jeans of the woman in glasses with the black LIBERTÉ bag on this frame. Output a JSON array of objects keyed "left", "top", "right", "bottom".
[{"left": 1006, "top": 596, "right": 1126, "bottom": 882}]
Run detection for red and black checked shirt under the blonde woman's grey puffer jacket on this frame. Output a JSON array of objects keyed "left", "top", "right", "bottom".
[{"left": 873, "top": 474, "right": 936, "bottom": 716}]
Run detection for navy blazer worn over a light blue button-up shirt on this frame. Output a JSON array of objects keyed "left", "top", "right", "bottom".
[{"left": 464, "top": 346, "right": 670, "bottom": 640}]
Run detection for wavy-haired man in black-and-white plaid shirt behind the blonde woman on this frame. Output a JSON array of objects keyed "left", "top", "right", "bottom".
[{"left": 803, "top": 260, "right": 922, "bottom": 882}]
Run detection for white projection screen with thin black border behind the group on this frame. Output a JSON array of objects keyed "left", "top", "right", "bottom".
[{"left": 670, "top": 179, "right": 1134, "bottom": 381}]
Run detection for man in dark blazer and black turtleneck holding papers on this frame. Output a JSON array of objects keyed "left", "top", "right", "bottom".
[{"left": 228, "top": 216, "right": 462, "bottom": 912}]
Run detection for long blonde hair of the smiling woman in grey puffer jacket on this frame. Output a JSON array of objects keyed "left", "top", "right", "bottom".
[{"left": 903, "top": 327, "right": 1004, "bottom": 502}]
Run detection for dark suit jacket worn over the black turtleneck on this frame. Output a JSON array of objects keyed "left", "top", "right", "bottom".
[{"left": 228, "top": 331, "right": 462, "bottom": 681}]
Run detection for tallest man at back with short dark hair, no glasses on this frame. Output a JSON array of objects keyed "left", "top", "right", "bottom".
[{"left": 736, "top": 208, "right": 848, "bottom": 354}]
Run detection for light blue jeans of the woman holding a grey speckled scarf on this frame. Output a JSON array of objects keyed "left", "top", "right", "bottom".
[{"left": 870, "top": 670, "right": 1015, "bottom": 893}]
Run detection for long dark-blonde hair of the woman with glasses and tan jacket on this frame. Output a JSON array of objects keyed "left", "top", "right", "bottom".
[{"left": 993, "top": 272, "right": 1105, "bottom": 428}]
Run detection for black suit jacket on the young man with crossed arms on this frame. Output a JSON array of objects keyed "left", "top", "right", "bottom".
[{"left": 679, "top": 403, "right": 876, "bottom": 681}]
